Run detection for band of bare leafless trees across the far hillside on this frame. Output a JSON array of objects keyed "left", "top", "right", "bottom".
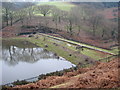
[{"left": 2, "top": 2, "right": 118, "bottom": 39}]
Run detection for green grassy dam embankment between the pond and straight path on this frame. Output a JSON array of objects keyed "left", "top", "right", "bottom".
[{"left": 2, "top": 35, "right": 113, "bottom": 64}]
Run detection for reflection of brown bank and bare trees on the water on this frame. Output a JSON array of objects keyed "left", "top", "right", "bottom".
[{"left": 2, "top": 41, "right": 55, "bottom": 66}]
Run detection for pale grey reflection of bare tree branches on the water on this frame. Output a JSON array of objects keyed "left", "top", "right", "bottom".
[{"left": 2, "top": 46, "right": 55, "bottom": 66}]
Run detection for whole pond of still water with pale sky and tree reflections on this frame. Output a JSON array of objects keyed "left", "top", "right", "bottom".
[{"left": 0, "top": 41, "right": 74, "bottom": 84}]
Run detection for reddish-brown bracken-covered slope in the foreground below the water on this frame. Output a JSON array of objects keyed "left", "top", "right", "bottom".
[{"left": 11, "top": 57, "right": 120, "bottom": 89}]
